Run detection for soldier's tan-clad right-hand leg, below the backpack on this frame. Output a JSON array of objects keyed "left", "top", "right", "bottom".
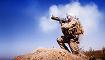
[{"left": 68, "top": 39, "right": 79, "bottom": 54}]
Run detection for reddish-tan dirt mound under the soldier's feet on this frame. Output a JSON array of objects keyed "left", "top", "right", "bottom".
[{"left": 15, "top": 48, "right": 86, "bottom": 60}]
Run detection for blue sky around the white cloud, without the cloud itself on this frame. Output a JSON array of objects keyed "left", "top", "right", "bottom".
[{"left": 0, "top": 0, "right": 105, "bottom": 57}]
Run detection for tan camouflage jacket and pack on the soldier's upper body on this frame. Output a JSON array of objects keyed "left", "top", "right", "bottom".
[{"left": 61, "top": 19, "right": 84, "bottom": 35}]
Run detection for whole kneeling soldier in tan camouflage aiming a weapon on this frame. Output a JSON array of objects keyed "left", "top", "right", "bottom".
[{"left": 51, "top": 15, "right": 83, "bottom": 54}]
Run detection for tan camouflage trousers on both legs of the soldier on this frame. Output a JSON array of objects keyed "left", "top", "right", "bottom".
[{"left": 57, "top": 36, "right": 79, "bottom": 54}]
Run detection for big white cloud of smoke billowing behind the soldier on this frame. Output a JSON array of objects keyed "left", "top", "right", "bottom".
[{"left": 40, "top": 2, "right": 105, "bottom": 49}]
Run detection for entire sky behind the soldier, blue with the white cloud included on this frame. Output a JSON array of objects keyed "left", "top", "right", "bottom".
[{"left": 0, "top": 0, "right": 105, "bottom": 57}]
